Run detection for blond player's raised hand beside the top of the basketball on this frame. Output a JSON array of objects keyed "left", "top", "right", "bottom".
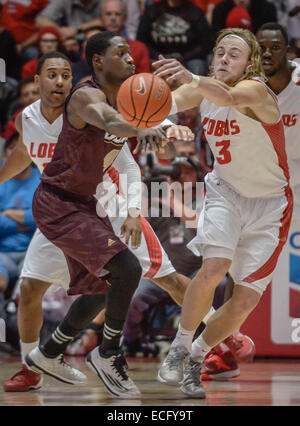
[{"left": 152, "top": 55, "right": 193, "bottom": 85}]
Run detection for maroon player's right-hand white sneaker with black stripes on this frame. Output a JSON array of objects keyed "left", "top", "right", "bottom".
[{"left": 86, "top": 346, "right": 141, "bottom": 399}]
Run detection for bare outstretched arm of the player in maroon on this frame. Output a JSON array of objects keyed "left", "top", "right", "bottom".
[{"left": 68, "top": 88, "right": 165, "bottom": 149}]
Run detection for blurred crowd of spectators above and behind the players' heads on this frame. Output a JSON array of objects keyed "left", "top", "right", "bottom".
[{"left": 0, "top": 0, "right": 300, "bottom": 144}]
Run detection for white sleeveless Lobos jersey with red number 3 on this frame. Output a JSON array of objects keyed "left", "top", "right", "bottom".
[{"left": 200, "top": 86, "right": 289, "bottom": 198}]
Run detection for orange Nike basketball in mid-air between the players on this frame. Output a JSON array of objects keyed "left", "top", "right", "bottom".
[{"left": 117, "top": 73, "right": 172, "bottom": 128}]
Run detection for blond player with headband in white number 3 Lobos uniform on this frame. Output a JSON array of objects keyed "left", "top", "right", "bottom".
[{"left": 154, "top": 28, "right": 293, "bottom": 398}]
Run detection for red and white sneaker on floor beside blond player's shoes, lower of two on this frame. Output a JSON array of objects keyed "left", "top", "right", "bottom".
[{"left": 201, "top": 343, "right": 240, "bottom": 381}]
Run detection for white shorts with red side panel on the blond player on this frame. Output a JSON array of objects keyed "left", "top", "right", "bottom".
[{"left": 188, "top": 175, "right": 293, "bottom": 294}]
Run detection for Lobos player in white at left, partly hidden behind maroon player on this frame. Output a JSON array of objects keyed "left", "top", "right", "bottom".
[{"left": 0, "top": 47, "right": 190, "bottom": 392}]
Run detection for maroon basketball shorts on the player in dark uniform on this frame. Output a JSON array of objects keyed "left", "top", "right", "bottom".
[{"left": 32, "top": 183, "right": 127, "bottom": 295}]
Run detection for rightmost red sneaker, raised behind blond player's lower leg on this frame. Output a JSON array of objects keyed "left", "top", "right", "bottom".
[{"left": 223, "top": 331, "right": 255, "bottom": 362}]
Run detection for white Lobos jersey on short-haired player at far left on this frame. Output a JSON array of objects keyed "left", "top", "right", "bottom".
[{"left": 22, "top": 99, "right": 63, "bottom": 173}]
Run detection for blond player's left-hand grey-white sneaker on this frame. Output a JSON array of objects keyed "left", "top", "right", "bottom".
[{"left": 157, "top": 345, "right": 189, "bottom": 386}]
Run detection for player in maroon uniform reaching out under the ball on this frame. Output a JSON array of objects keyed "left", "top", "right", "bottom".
[{"left": 19, "top": 32, "right": 197, "bottom": 398}]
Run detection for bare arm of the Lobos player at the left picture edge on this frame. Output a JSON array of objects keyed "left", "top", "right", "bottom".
[{"left": 0, "top": 113, "right": 31, "bottom": 183}]
